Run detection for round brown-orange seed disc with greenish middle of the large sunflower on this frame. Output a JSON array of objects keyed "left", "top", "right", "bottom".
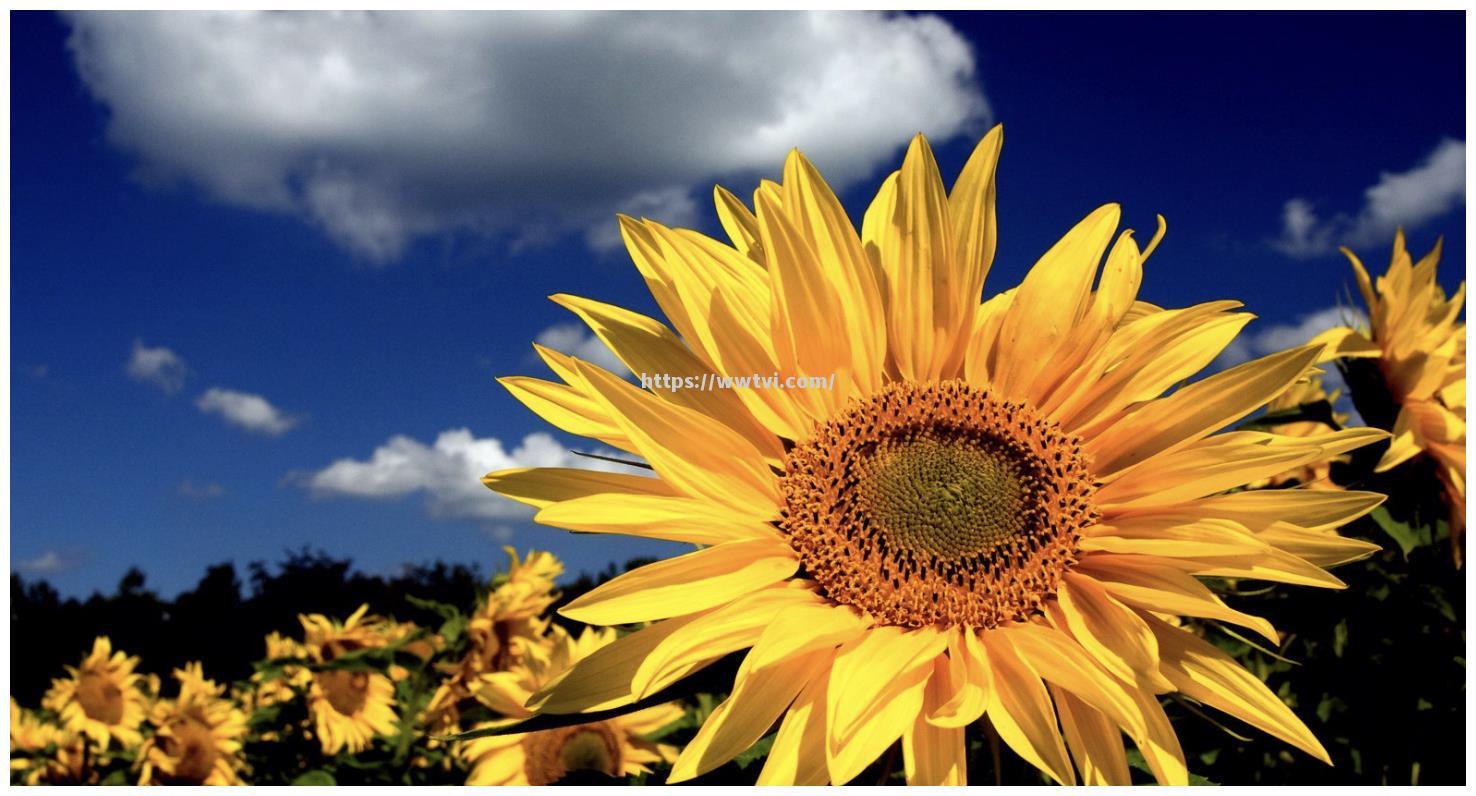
[{"left": 781, "top": 381, "right": 1095, "bottom": 628}]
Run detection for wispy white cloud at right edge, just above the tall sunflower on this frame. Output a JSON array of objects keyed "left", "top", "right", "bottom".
[{"left": 1272, "top": 139, "right": 1466, "bottom": 257}]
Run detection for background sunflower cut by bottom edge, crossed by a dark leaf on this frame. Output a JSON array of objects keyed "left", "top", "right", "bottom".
[{"left": 461, "top": 626, "right": 682, "bottom": 786}]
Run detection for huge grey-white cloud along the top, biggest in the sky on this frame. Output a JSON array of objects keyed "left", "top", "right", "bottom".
[{"left": 68, "top": 12, "right": 989, "bottom": 263}]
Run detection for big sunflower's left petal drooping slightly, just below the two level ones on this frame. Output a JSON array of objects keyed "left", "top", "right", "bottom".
[{"left": 559, "top": 539, "right": 800, "bottom": 625}]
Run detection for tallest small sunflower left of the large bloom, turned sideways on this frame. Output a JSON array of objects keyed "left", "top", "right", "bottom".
[{"left": 427, "top": 546, "right": 564, "bottom": 731}]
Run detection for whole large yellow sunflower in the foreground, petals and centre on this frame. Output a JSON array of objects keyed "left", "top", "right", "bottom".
[{"left": 486, "top": 128, "right": 1384, "bottom": 783}]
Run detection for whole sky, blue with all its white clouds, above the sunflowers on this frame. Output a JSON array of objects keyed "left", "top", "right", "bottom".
[{"left": 10, "top": 13, "right": 1466, "bottom": 594}]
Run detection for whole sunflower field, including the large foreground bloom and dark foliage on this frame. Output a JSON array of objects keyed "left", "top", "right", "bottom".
[{"left": 10, "top": 127, "right": 1466, "bottom": 786}]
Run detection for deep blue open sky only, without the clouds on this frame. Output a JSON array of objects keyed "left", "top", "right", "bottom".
[{"left": 10, "top": 13, "right": 1466, "bottom": 595}]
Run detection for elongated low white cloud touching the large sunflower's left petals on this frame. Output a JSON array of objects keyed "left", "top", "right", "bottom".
[{"left": 302, "top": 428, "right": 624, "bottom": 527}]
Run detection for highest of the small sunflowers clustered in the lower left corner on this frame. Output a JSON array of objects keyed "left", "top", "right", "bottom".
[{"left": 41, "top": 637, "right": 156, "bottom": 749}]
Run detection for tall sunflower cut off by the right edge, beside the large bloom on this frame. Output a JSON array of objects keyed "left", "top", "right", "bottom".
[{"left": 1314, "top": 230, "right": 1466, "bottom": 561}]
